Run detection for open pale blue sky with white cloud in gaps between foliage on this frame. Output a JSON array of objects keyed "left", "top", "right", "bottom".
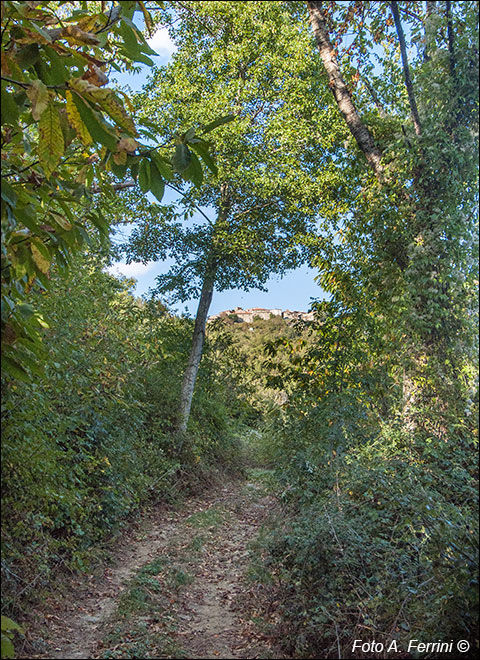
[{"left": 108, "top": 21, "right": 325, "bottom": 316}]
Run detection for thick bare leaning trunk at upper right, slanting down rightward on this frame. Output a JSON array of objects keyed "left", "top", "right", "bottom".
[{"left": 307, "top": 0, "right": 383, "bottom": 180}]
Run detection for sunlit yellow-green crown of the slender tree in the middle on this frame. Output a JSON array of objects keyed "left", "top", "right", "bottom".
[{"left": 119, "top": 2, "right": 339, "bottom": 300}]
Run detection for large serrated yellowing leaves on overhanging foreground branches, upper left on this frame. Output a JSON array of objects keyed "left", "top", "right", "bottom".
[{"left": 2, "top": 2, "right": 216, "bottom": 380}]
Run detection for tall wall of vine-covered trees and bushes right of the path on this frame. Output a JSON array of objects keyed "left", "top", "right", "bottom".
[{"left": 249, "top": 3, "right": 478, "bottom": 657}]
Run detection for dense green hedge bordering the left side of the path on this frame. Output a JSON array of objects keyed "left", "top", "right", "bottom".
[{"left": 2, "top": 258, "right": 246, "bottom": 605}]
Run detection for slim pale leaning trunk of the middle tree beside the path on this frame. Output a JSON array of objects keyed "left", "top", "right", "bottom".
[{"left": 177, "top": 263, "right": 217, "bottom": 434}]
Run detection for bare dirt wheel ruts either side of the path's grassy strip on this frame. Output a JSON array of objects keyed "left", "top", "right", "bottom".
[{"left": 23, "top": 481, "right": 284, "bottom": 659}]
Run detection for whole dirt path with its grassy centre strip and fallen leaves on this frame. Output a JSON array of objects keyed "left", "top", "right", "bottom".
[{"left": 21, "top": 471, "right": 284, "bottom": 658}]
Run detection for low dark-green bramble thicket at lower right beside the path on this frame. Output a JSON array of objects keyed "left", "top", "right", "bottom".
[{"left": 262, "top": 422, "right": 478, "bottom": 658}]
